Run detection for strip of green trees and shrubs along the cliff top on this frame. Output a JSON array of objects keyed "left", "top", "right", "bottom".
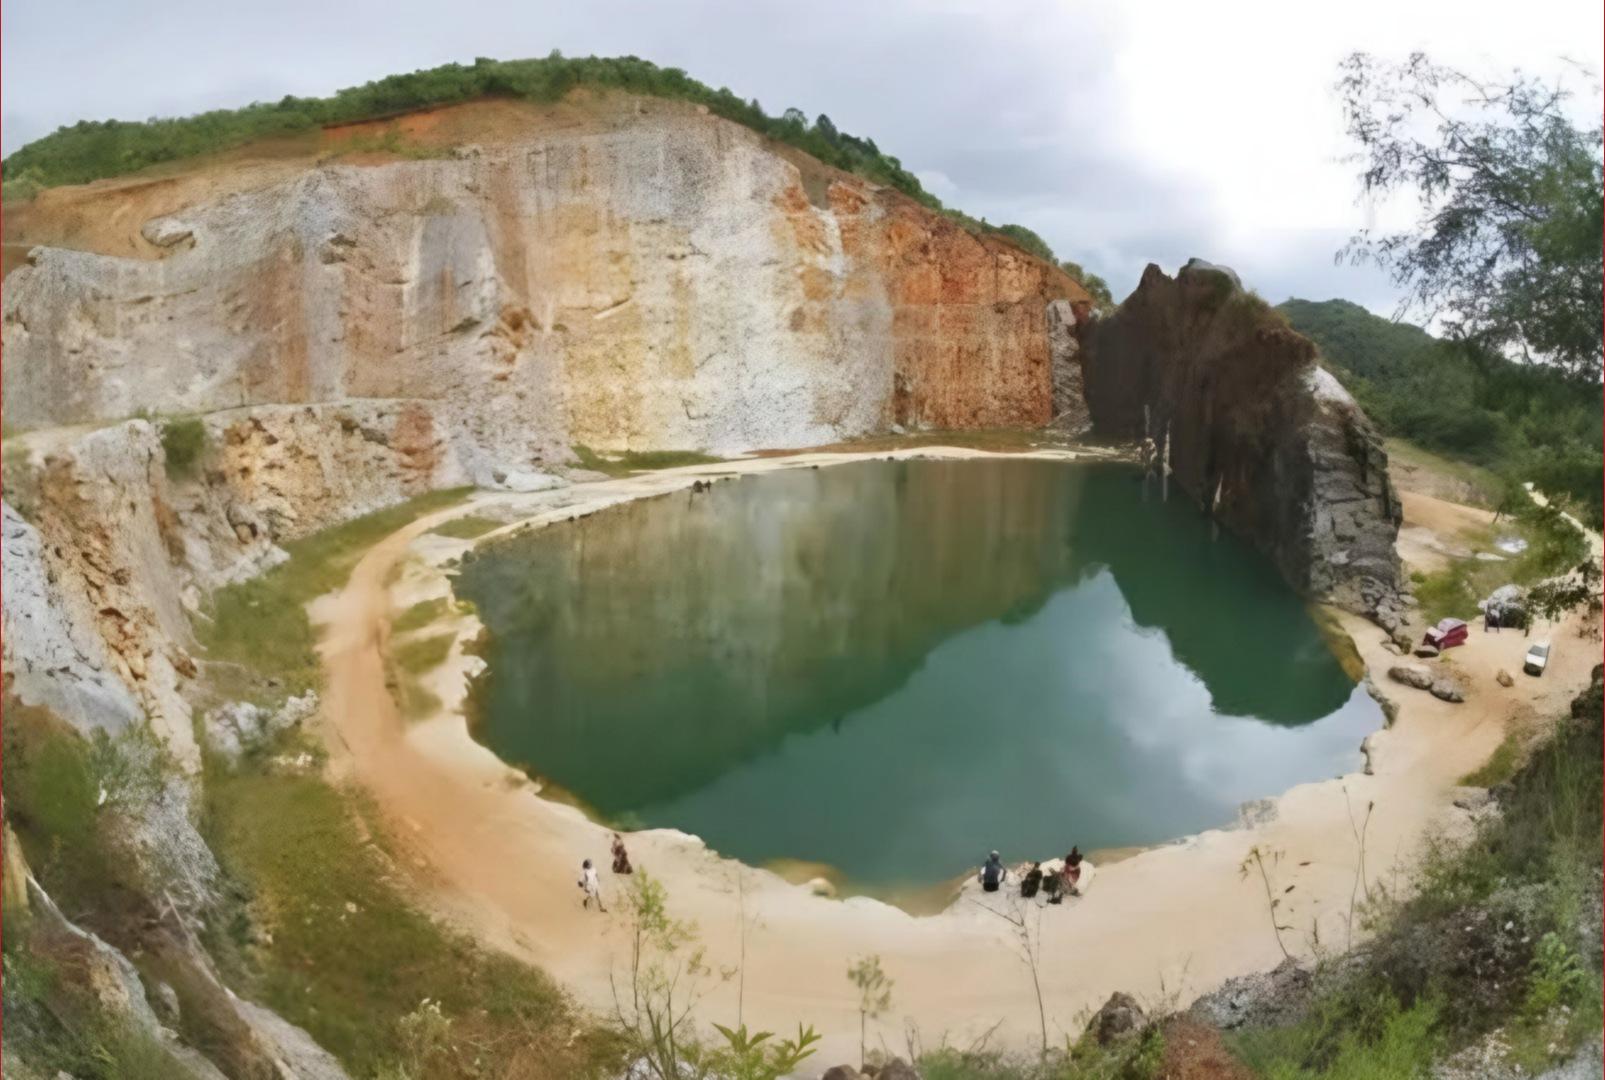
[{"left": 3, "top": 51, "right": 1091, "bottom": 274}]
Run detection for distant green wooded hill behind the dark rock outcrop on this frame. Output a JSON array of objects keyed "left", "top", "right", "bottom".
[{"left": 1278, "top": 300, "right": 1605, "bottom": 525}]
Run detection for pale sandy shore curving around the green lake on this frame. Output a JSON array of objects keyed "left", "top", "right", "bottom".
[{"left": 315, "top": 448, "right": 1599, "bottom": 1067}]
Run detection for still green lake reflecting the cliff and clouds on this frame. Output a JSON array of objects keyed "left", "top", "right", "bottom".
[{"left": 457, "top": 459, "right": 1382, "bottom": 889}]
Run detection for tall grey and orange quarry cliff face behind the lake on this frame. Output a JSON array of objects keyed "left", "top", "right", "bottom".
[{"left": 3, "top": 96, "right": 1085, "bottom": 483}]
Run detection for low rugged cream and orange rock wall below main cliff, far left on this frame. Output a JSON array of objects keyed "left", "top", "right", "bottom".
[{"left": 0, "top": 401, "right": 464, "bottom": 767}]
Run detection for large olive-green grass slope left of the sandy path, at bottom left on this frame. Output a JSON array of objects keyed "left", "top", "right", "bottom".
[{"left": 205, "top": 741, "right": 607, "bottom": 1078}]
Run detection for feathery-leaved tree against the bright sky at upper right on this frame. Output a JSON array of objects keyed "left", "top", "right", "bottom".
[{"left": 1337, "top": 53, "right": 1605, "bottom": 379}]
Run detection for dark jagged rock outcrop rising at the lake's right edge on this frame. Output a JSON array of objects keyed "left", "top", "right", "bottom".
[{"left": 1079, "top": 262, "right": 1401, "bottom": 615}]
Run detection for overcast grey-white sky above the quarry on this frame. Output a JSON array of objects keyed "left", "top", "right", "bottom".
[{"left": 0, "top": 0, "right": 1605, "bottom": 315}]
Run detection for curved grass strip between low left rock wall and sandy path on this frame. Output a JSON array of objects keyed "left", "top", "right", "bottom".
[{"left": 196, "top": 488, "right": 470, "bottom": 696}]
